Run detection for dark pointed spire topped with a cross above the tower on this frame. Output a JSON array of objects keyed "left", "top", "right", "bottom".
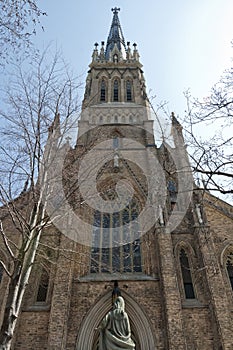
[{"left": 105, "top": 7, "right": 126, "bottom": 60}]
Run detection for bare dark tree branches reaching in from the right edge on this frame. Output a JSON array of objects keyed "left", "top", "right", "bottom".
[{"left": 183, "top": 68, "right": 233, "bottom": 198}]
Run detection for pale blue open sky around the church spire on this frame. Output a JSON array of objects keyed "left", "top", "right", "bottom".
[{"left": 36, "top": 0, "right": 233, "bottom": 115}]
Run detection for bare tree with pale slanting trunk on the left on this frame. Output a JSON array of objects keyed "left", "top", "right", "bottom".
[{"left": 0, "top": 48, "right": 80, "bottom": 349}]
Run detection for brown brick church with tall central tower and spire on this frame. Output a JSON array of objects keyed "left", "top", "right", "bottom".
[{"left": 0, "top": 8, "right": 233, "bottom": 350}]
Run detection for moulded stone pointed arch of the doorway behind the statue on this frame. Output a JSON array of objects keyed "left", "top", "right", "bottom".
[{"left": 75, "top": 292, "right": 157, "bottom": 350}]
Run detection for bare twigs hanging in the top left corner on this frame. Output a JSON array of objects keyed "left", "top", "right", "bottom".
[{"left": 0, "top": 0, "right": 46, "bottom": 64}]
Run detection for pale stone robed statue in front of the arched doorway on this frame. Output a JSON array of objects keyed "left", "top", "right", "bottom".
[{"left": 99, "top": 296, "right": 135, "bottom": 350}]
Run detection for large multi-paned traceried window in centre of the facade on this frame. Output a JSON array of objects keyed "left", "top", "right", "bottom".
[{"left": 91, "top": 200, "right": 142, "bottom": 273}]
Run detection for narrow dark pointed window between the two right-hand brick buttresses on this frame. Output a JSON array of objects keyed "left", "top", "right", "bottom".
[{"left": 180, "top": 249, "right": 195, "bottom": 299}]
